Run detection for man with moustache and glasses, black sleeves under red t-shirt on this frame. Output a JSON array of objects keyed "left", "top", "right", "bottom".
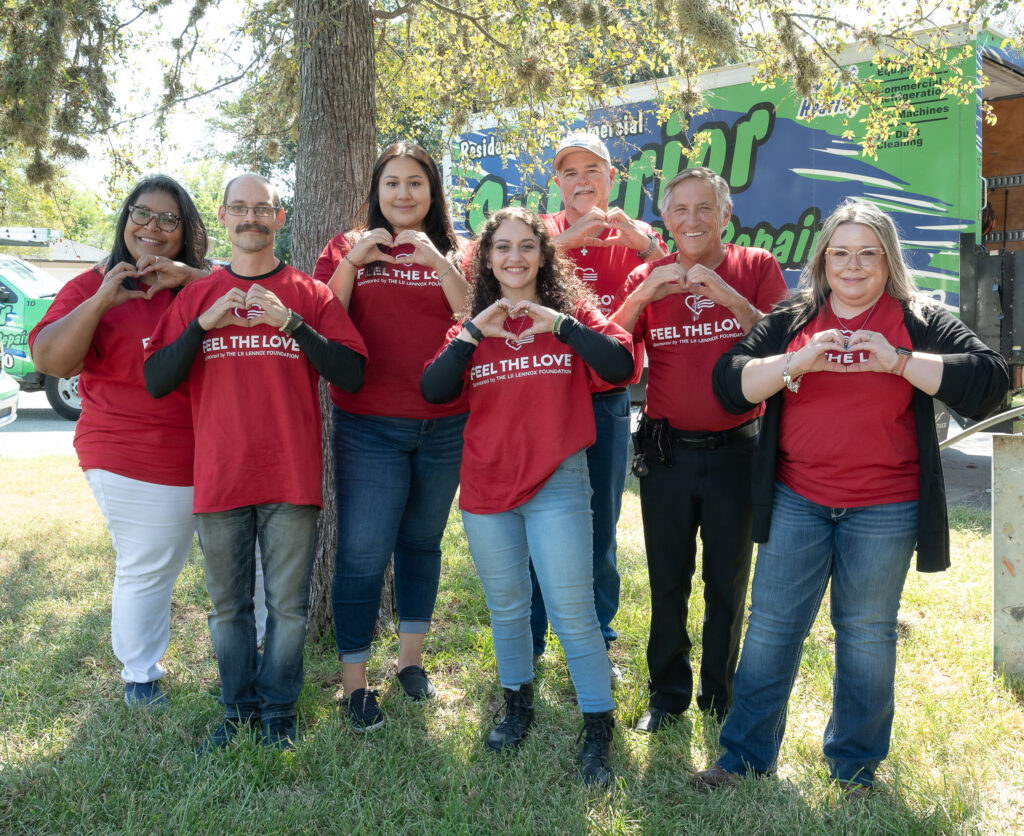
[{"left": 144, "top": 174, "right": 367, "bottom": 751}]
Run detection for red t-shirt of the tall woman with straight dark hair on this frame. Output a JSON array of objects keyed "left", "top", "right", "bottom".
[{"left": 313, "top": 235, "right": 469, "bottom": 420}]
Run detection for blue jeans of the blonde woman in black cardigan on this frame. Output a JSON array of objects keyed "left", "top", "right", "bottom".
[{"left": 718, "top": 483, "right": 918, "bottom": 786}]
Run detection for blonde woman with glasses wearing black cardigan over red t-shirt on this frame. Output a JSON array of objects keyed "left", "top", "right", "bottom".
[{"left": 694, "top": 201, "right": 1009, "bottom": 798}]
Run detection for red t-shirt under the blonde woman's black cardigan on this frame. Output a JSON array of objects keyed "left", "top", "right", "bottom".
[{"left": 776, "top": 295, "right": 921, "bottom": 508}]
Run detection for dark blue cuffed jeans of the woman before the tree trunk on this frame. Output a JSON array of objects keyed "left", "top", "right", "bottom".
[{"left": 331, "top": 407, "right": 469, "bottom": 663}]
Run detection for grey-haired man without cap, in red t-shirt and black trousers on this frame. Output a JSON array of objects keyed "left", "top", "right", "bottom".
[{"left": 611, "top": 168, "right": 787, "bottom": 733}]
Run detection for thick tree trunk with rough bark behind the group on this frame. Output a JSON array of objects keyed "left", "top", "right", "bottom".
[{"left": 292, "top": 0, "right": 377, "bottom": 636}]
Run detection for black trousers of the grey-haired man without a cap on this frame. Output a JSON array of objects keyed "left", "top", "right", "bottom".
[{"left": 640, "top": 438, "right": 757, "bottom": 717}]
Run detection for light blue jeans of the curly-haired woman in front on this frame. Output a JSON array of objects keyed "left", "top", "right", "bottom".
[{"left": 462, "top": 450, "right": 614, "bottom": 712}]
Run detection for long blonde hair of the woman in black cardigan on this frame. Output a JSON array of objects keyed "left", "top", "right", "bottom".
[{"left": 794, "top": 198, "right": 926, "bottom": 322}]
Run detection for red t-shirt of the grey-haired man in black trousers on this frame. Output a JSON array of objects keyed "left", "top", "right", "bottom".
[{"left": 615, "top": 244, "right": 788, "bottom": 424}]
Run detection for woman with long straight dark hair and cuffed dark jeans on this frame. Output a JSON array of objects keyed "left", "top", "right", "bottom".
[{"left": 313, "top": 142, "right": 469, "bottom": 732}]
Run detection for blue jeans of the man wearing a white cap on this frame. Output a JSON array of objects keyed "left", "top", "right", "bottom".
[{"left": 529, "top": 390, "right": 630, "bottom": 655}]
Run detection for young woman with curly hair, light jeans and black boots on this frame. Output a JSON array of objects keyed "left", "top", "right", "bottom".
[{"left": 421, "top": 208, "right": 633, "bottom": 784}]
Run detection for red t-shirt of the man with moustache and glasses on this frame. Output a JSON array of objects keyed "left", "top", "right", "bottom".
[{"left": 145, "top": 264, "right": 367, "bottom": 513}]
